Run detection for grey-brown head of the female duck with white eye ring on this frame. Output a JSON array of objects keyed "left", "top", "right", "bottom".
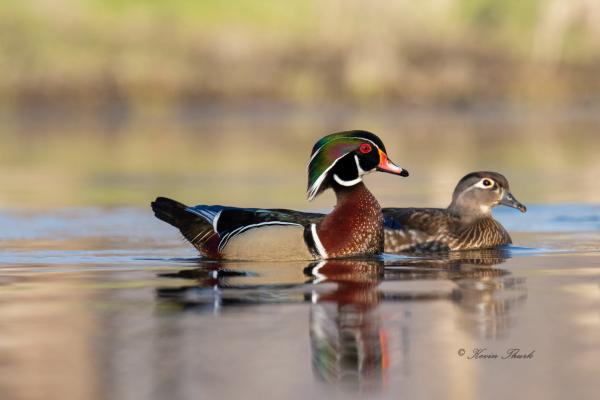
[{"left": 449, "top": 171, "right": 527, "bottom": 217}]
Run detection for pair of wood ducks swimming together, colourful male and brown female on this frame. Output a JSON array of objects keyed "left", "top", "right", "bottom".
[{"left": 152, "top": 131, "right": 525, "bottom": 260}]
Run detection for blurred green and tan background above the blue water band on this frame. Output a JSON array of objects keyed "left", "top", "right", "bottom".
[{"left": 0, "top": 0, "right": 600, "bottom": 208}]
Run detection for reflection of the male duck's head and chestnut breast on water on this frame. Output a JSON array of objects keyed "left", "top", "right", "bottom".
[{"left": 308, "top": 260, "right": 390, "bottom": 392}]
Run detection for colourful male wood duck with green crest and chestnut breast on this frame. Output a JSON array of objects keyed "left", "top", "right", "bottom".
[{"left": 152, "top": 131, "right": 408, "bottom": 260}]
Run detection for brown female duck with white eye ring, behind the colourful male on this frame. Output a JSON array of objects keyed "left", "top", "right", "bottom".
[{"left": 383, "top": 171, "right": 527, "bottom": 253}]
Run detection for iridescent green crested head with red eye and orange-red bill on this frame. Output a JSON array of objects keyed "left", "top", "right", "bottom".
[{"left": 307, "top": 131, "right": 408, "bottom": 200}]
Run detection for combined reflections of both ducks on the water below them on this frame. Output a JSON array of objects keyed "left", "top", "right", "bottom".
[{"left": 157, "top": 250, "right": 527, "bottom": 392}]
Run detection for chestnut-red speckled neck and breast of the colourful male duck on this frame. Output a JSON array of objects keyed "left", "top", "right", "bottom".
[{"left": 316, "top": 182, "right": 383, "bottom": 258}]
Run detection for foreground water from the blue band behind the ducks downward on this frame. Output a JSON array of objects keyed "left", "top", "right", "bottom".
[{"left": 0, "top": 205, "right": 600, "bottom": 400}]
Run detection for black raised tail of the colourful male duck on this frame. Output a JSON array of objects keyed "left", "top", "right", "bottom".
[{"left": 151, "top": 197, "right": 213, "bottom": 247}]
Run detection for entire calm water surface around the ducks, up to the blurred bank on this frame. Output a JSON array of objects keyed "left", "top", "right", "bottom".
[{"left": 0, "top": 104, "right": 600, "bottom": 400}]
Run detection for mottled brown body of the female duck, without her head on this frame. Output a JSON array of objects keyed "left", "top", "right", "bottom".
[{"left": 383, "top": 208, "right": 512, "bottom": 253}]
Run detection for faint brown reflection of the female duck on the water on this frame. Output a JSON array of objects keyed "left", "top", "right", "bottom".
[{"left": 384, "top": 248, "right": 527, "bottom": 340}]
